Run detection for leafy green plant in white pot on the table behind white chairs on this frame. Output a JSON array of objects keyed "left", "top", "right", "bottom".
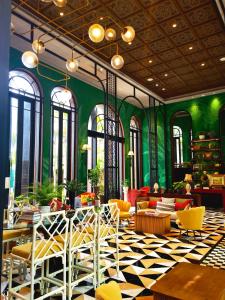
[{"left": 29, "top": 181, "right": 62, "bottom": 213}]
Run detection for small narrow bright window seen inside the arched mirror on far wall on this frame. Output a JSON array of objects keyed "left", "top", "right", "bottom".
[{"left": 173, "top": 126, "right": 183, "bottom": 167}]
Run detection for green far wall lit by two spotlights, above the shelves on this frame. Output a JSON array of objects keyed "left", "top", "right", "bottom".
[{"left": 166, "top": 93, "right": 225, "bottom": 186}]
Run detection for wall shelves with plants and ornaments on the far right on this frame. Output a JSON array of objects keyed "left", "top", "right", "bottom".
[{"left": 191, "top": 138, "right": 224, "bottom": 173}]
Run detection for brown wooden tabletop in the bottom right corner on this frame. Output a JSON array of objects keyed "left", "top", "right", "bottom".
[{"left": 151, "top": 263, "right": 225, "bottom": 300}]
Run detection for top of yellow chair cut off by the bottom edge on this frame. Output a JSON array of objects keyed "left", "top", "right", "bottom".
[{"left": 95, "top": 281, "right": 122, "bottom": 300}]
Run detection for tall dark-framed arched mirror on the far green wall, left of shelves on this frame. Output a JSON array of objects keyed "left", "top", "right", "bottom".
[{"left": 170, "top": 111, "right": 192, "bottom": 182}]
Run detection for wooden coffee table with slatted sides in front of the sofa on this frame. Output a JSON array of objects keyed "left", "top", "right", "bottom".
[{"left": 135, "top": 212, "right": 170, "bottom": 234}]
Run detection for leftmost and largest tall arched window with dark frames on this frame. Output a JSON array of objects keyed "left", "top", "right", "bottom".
[{"left": 9, "top": 70, "right": 42, "bottom": 197}]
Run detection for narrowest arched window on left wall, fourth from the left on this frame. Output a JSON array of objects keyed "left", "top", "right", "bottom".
[{"left": 130, "top": 117, "right": 142, "bottom": 189}]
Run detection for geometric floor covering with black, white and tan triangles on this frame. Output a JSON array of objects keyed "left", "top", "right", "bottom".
[{"left": 3, "top": 211, "right": 225, "bottom": 300}]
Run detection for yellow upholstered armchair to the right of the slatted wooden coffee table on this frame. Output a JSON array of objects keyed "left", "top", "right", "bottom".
[{"left": 176, "top": 206, "right": 205, "bottom": 236}]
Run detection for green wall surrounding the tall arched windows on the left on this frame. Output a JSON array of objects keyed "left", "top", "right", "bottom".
[{"left": 10, "top": 48, "right": 145, "bottom": 188}]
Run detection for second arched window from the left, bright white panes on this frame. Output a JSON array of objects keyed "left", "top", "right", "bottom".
[{"left": 51, "top": 87, "right": 77, "bottom": 184}]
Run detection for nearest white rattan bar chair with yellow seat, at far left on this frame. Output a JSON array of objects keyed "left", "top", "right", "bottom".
[{"left": 9, "top": 211, "right": 69, "bottom": 300}]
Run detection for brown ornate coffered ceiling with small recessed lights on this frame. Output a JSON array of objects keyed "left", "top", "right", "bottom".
[{"left": 11, "top": 0, "right": 225, "bottom": 100}]
